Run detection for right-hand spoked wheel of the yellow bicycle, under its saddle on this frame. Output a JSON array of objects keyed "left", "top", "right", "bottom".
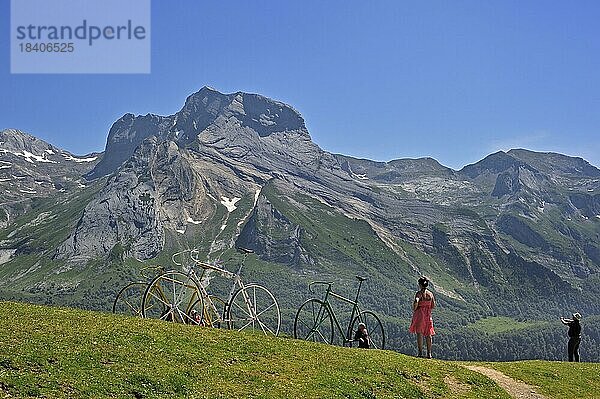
[{"left": 227, "top": 284, "right": 281, "bottom": 336}]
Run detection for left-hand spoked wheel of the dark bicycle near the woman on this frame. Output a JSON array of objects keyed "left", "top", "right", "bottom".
[{"left": 294, "top": 298, "right": 334, "bottom": 344}]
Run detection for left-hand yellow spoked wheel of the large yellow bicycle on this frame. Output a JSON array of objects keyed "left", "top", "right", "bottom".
[{"left": 142, "top": 271, "right": 202, "bottom": 324}]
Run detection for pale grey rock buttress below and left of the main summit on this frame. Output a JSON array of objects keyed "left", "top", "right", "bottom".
[{"left": 57, "top": 137, "right": 197, "bottom": 260}]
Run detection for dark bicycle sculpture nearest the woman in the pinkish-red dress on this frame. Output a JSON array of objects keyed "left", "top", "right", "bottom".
[{"left": 294, "top": 276, "right": 385, "bottom": 349}]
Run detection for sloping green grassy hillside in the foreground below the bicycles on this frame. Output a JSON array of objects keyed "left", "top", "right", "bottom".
[{"left": 0, "top": 302, "right": 600, "bottom": 398}]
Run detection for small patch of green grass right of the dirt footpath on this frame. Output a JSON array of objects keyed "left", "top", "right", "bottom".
[{"left": 485, "top": 360, "right": 600, "bottom": 399}]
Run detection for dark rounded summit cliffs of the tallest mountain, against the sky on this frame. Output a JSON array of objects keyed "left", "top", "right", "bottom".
[{"left": 86, "top": 86, "right": 310, "bottom": 179}]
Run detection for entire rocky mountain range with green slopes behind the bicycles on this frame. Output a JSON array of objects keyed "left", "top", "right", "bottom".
[{"left": 0, "top": 87, "right": 600, "bottom": 362}]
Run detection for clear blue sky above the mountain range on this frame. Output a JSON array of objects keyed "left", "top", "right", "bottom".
[{"left": 0, "top": 0, "right": 600, "bottom": 168}]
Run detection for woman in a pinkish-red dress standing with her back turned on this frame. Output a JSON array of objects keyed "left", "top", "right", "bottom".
[{"left": 408, "top": 276, "right": 435, "bottom": 359}]
